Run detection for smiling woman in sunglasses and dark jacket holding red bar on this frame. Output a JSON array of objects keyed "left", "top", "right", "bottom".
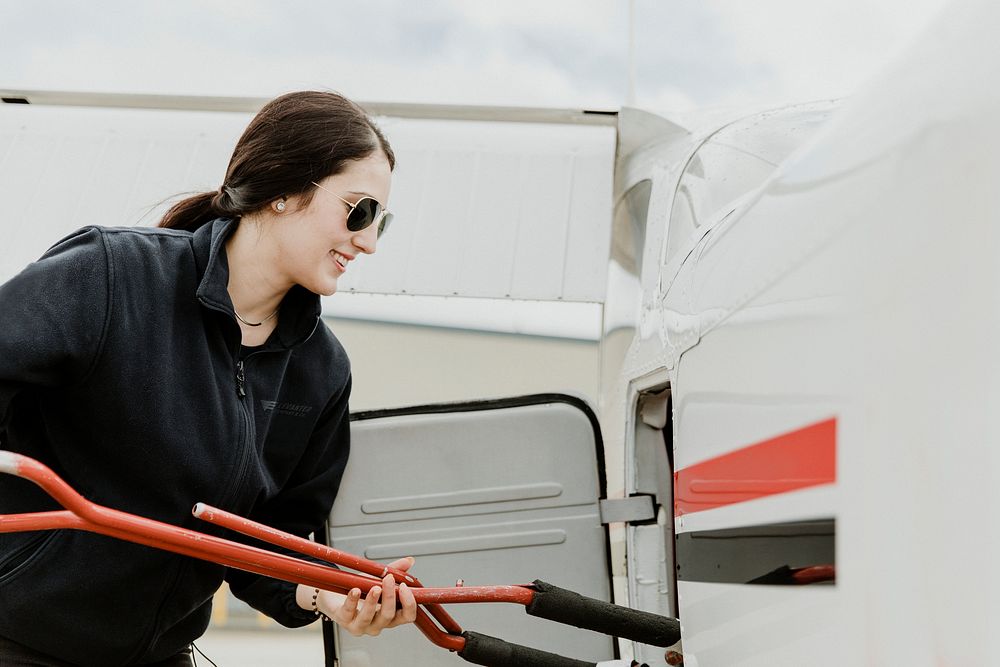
[{"left": 0, "top": 92, "right": 416, "bottom": 665}]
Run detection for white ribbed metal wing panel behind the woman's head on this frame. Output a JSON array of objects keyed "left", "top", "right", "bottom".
[{"left": 0, "top": 105, "right": 615, "bottom": 302}]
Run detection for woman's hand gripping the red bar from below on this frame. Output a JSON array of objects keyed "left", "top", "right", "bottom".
[{"left": 299, "top": 557, "right": 417, "bottom": 637}]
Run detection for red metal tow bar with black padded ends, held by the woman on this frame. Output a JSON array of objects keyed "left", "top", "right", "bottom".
[{"left": 0, "top": 451, "right": 680, "bottom": 667}]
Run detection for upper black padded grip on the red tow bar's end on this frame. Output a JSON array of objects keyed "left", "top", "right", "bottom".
[{"left": 526, "top": 580, "right": 681, "bottom": 647}]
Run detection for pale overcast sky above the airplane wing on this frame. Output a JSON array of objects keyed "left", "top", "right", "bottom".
[{"left": 0, "top": 0, "right": 947, "bottom": 111}]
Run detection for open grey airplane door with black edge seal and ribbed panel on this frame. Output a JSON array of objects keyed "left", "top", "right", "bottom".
[{"left": 324, "top": 394, "right": 615, "bottom": 667}]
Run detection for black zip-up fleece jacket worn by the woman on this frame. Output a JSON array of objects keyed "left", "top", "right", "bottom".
[{"left": 0, "top": 219, "right": 351, "bottom": 666}]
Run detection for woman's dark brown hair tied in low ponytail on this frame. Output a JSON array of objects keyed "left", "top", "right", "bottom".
[{"left": 159, "top": 91, "right": 396, "bottom": 231}]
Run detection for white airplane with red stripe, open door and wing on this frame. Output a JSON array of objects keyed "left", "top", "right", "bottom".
[{"left": 0, "top": 0, "right": 1000, "bottom": 667}]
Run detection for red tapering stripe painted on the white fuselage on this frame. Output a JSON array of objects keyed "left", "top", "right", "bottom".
[{"left": 674, "top": 418, "right": 837, "bottom": 516}]
